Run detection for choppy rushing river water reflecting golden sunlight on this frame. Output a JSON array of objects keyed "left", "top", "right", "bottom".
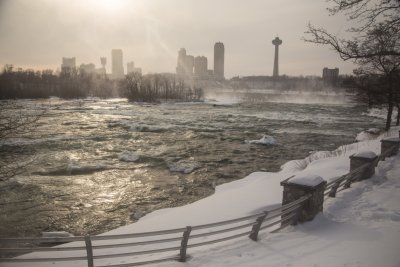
[{"left": 0, "top": 99, "right": 382, "bottom": 236}]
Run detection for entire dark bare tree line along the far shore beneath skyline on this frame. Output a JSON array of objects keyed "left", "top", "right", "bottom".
[{"left": 0, "top": 65, "right": 203, "bottom": 102}]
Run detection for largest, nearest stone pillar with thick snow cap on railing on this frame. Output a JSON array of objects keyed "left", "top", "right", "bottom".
[{"left": 281, "top": 175, "right": 326, "bottom": 224}]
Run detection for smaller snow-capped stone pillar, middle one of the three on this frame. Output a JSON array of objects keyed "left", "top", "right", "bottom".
[{"left": 350, "top": 151, "right": 378, "bottom": 181}]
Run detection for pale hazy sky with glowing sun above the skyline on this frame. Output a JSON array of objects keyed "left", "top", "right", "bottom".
[{"left": 0, "top": 0, "right": 354, "bottom": 78}]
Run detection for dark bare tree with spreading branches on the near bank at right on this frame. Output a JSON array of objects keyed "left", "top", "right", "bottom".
[{"left": 304, "top": 0, "right": 400, "bottom": 130}]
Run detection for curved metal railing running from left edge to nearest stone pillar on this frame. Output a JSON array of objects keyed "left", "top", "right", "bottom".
[{"left": 0, "top": 195, "right": 310, "bottom": 267}]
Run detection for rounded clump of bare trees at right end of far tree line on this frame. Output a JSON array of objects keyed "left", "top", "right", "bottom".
[{"left": 119, "top": 73, "right": 203, "bottom": 102}]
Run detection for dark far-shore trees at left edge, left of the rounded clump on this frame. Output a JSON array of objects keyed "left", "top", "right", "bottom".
[{"left": 0, "top": 65, "right": 114, "bottom": 99}]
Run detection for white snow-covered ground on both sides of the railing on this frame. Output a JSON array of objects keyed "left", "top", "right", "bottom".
[{"left": 6, "top": 128, "right": 400, "bottom": 267}]
